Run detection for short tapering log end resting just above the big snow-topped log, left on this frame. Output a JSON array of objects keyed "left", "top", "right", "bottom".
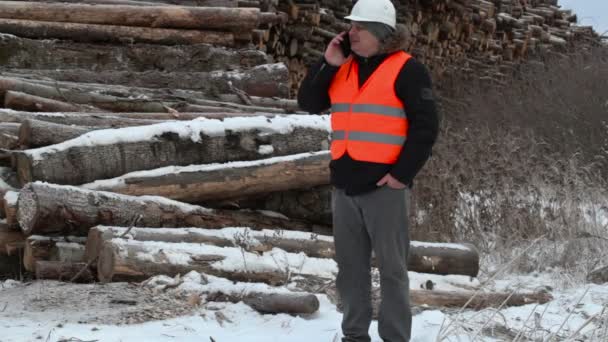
[{"left": 19, "top": 119, "right": 94, "bottom": 148}]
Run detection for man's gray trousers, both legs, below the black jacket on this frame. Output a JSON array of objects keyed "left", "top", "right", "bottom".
[{"left": 332, "top": 186, "right": 412, "bottom": 342}]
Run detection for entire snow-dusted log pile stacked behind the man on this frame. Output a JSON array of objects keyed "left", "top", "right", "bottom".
[{"left": 0, "top": 0, "right": 568, "bottom": 313}]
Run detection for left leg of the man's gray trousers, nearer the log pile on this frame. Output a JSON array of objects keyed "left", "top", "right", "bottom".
[{"left": 332, "top": 189, "right": 372, "bottom": 342}]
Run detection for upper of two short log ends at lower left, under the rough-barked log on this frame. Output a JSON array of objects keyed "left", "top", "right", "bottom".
[{"left": 23, "top": 235, "right": 86, "bottom": 272}]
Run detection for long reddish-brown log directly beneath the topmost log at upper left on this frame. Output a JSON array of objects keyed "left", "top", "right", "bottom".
[{"left": 0, "top": 19, "right": 234, "bottom": 46}]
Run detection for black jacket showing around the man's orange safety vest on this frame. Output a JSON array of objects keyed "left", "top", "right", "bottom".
[{"left": 298, "top": 54, "right": 439, "bottom": 196}]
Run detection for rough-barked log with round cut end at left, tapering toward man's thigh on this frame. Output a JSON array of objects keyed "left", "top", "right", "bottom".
[{"left": 18, "top": 182, "right": 331, "bottom": 236}]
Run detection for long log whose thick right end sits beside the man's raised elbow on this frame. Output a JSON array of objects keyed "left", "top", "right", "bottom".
[{"left": 14, "top": 63, "right": 289, "bottom": 97}]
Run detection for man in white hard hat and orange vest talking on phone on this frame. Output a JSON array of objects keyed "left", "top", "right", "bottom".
[{"left": 298, "top": 0, "right": 439, "bottom": 342}]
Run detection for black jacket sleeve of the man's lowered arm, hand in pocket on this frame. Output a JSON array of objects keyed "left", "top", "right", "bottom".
[{"left": 390, "top": 58, "right": 439, "bottom": 186}]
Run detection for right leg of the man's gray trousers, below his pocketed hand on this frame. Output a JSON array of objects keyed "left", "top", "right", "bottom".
[{"left": 359, "top": 186, "right": 412, "bottom": 342}]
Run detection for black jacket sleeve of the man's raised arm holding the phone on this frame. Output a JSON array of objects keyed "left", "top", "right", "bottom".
[{"left": 298, "top": 58, "right": 339, "bottom": 114}]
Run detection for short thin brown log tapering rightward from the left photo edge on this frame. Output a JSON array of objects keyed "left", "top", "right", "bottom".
[{"left": 4, "top": 90, "right": 92, "bottom": 112}]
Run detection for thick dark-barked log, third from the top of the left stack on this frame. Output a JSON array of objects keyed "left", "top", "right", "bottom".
[{"left": 0, "top": 35, "right": 271, "bottom": 72}]
